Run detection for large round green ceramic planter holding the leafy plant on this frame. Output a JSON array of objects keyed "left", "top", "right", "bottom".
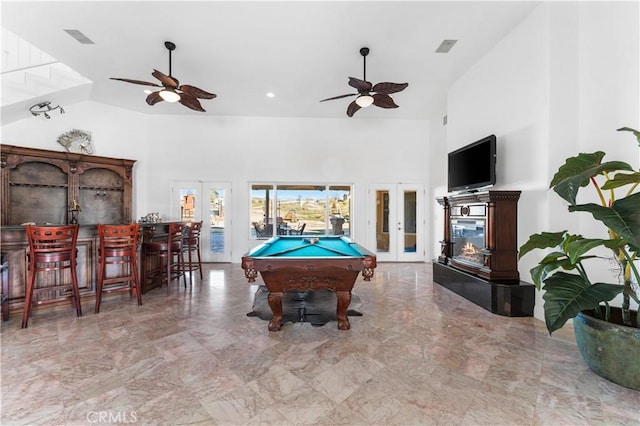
[{"left": 573, "top": 308, "right": 640, "bottom": 390}]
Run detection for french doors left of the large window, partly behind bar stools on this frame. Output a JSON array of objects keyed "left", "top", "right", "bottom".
[{"left": 171, "top": 181, "right": 232, "bottom": 262}]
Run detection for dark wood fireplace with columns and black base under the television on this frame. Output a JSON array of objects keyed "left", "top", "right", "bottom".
[{"left": 433, "top": 191, "right": 535, "bottom": 316}]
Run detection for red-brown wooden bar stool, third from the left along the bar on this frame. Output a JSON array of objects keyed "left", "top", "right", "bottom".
[{"left": 145, "top": 222, "right": 187, "bottom": 294}]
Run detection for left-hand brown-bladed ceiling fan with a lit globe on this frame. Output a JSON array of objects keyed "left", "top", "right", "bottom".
[{"left": 111, "top": 41, "right": 216, "bottom": 112}]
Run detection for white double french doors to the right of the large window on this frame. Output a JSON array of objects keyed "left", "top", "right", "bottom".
[{"left": 367, "top": 183, "right": 425, "bottom": 262}]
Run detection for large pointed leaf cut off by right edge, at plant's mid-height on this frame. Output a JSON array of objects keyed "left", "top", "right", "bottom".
[{"left": 569, "top": 192, "right": 640, "bottom": 252}]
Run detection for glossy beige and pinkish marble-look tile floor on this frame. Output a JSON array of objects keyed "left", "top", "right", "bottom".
[{"left": 0, "top": 263, "right": 640, "bottom": 425}]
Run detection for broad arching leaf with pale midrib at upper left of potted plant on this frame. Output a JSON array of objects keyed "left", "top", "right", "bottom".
[{"left": 549, "top": 151, "right": 633, "bottom": 205}]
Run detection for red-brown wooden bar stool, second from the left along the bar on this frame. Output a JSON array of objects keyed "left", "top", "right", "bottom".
[{"left": 96, "top": 223, "right": 142, "bottom": 314}]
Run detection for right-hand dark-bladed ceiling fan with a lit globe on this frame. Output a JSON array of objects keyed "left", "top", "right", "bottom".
[{"left": 320, "top": 47, "right": 409, "bottom": 117}]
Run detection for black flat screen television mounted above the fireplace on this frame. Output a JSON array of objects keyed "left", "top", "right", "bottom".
[{"left": 448, "top": 135, "right": 496, "bottom": 192}]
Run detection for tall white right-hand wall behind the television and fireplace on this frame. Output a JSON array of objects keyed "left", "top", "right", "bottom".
[{"left": 440, "top": 2, "right": 640, "bottom": 318}]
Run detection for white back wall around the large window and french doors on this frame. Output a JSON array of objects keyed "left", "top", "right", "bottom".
[{"left": 140, "top": 116, "right": 429, "bottom": 262}]
